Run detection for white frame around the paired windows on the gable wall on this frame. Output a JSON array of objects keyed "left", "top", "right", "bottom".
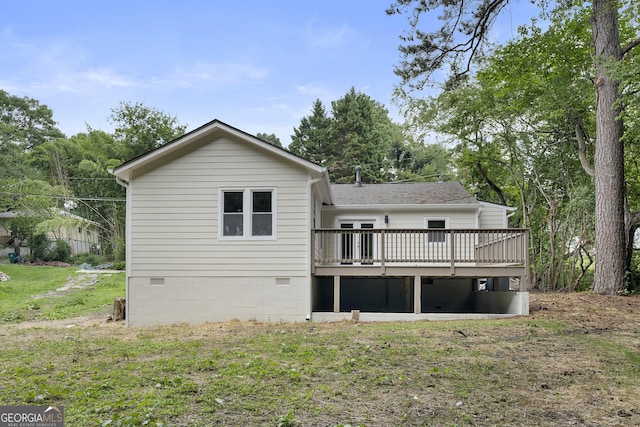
[{"left": 218, "top": 187, "right": 278, "bottom": 240}]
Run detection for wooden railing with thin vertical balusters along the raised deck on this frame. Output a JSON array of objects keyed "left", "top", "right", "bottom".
[{"left": 313, "top": 228, "right": 528, "bottom": 267}]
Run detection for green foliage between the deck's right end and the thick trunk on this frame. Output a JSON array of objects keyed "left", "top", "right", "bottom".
[{"left": 404, "top": 4, "right": 616, "bottom": 289}]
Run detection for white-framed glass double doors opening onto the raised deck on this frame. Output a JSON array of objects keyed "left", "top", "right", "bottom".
[{"left": 339, "top": 220, "right": 377, "bottom": 265}]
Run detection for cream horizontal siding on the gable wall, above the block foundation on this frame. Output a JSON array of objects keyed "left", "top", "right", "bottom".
[{"left": 129, "top": 138, "right": 310, "bottom": 277}]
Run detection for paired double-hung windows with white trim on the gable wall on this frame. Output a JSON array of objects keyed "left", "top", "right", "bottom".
[{"left": 220, "top": 189, "right": 275, "bottom": 239}]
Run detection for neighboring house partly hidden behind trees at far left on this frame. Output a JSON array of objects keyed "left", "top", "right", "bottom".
[{"left": 0, "top": 211, "right": 100, "bottom": 256}]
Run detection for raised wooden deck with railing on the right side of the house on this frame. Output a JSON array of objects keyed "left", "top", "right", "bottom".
[{"left": 312, "top": 228, "right": 529, "bottom": 290}]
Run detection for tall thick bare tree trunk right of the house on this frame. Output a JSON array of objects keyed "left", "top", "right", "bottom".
[{"left": 591, "top": 0, "right": 625, "bottom": 294}]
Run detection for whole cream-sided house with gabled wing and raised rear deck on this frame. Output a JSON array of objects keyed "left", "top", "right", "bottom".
[{"left": 111, "top": 120, "right": 529, "bottom": 325}]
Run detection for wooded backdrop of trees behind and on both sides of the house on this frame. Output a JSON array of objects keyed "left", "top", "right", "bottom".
[{"left": 0, "top": 0, "right": 640, "bottom": 293}]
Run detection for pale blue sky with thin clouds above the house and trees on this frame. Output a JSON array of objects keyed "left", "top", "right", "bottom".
[{"left": 0, "top": 0, "right": 526, "bottom": 145}]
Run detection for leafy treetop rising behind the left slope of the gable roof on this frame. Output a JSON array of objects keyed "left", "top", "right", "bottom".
[{"left": 110, "top": 102, "right": 186, "bottom": 160}]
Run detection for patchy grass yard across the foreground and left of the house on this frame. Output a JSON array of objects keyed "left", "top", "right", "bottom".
[{"left": 0, "top": 265, "right": 640, "bottom": 427}]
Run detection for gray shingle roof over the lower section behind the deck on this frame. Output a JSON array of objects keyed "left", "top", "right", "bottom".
[{"left": 331, "top": 181, "right": 479, "bottom": 205}]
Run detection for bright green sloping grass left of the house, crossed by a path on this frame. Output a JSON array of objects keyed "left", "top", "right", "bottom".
[{"left": 0, "top": 264, "right": 125, "bottom": 323}]
